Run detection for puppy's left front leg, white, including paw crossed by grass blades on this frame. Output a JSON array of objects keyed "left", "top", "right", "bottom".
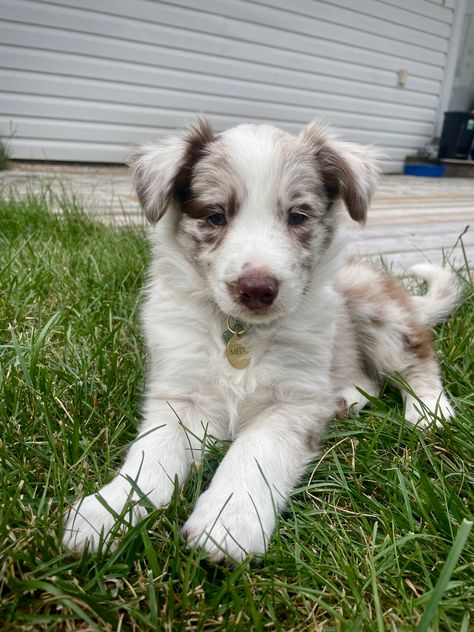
[{"left": 63, "top": 397, "right": 215, "bottom": 551}]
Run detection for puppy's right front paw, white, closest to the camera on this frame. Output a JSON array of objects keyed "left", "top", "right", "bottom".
[{"left": 183, "top": 489, "right": 275, "bottom": 562}]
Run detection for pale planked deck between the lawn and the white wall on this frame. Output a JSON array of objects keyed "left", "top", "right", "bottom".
[{"left": 0, "top": 162, "right": 474, "bottom": 272}]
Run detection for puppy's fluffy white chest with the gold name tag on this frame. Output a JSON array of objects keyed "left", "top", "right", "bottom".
[{"left": 143, "top": 282, "right": 332, "bottom": 402}]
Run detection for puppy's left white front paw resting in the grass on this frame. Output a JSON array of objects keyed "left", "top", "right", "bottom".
[{"left": 63, "top": 479, "right": 146, "bottom": 553}]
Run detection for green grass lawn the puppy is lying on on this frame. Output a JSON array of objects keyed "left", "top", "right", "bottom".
[{"left": 0, "top": 193, "right": 474, "bottom": 632}]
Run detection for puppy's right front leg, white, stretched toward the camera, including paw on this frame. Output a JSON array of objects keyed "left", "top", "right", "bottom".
[{"left": 183, "top": 402, "right": 334, "bottom": 560}]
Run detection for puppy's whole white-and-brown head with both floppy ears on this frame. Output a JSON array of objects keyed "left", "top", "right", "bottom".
[{"left": 133, "top": 119, "right": 378, "bottom": 322}]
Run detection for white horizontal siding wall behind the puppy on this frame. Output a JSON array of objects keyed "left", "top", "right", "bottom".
[{"left": 0, "top": 0, "right": 456, "bottom": 171}]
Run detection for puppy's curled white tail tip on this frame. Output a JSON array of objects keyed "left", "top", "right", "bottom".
[{"left": 410, "top": 263, "right": 462, "bottom": 325}]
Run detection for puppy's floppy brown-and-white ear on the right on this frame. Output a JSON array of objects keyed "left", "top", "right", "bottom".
[{"left": 302, "top": 121, "right": 380, "bottom": 224}]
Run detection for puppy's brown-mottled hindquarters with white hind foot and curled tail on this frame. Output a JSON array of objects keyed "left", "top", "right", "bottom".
[{"left": 337, "top": 263, "right": 458, "bottom": 427}]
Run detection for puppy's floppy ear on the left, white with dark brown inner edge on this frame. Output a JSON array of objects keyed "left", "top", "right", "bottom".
[{"left": 130, "top": 117, "right": 215, "bottom": 223}]
